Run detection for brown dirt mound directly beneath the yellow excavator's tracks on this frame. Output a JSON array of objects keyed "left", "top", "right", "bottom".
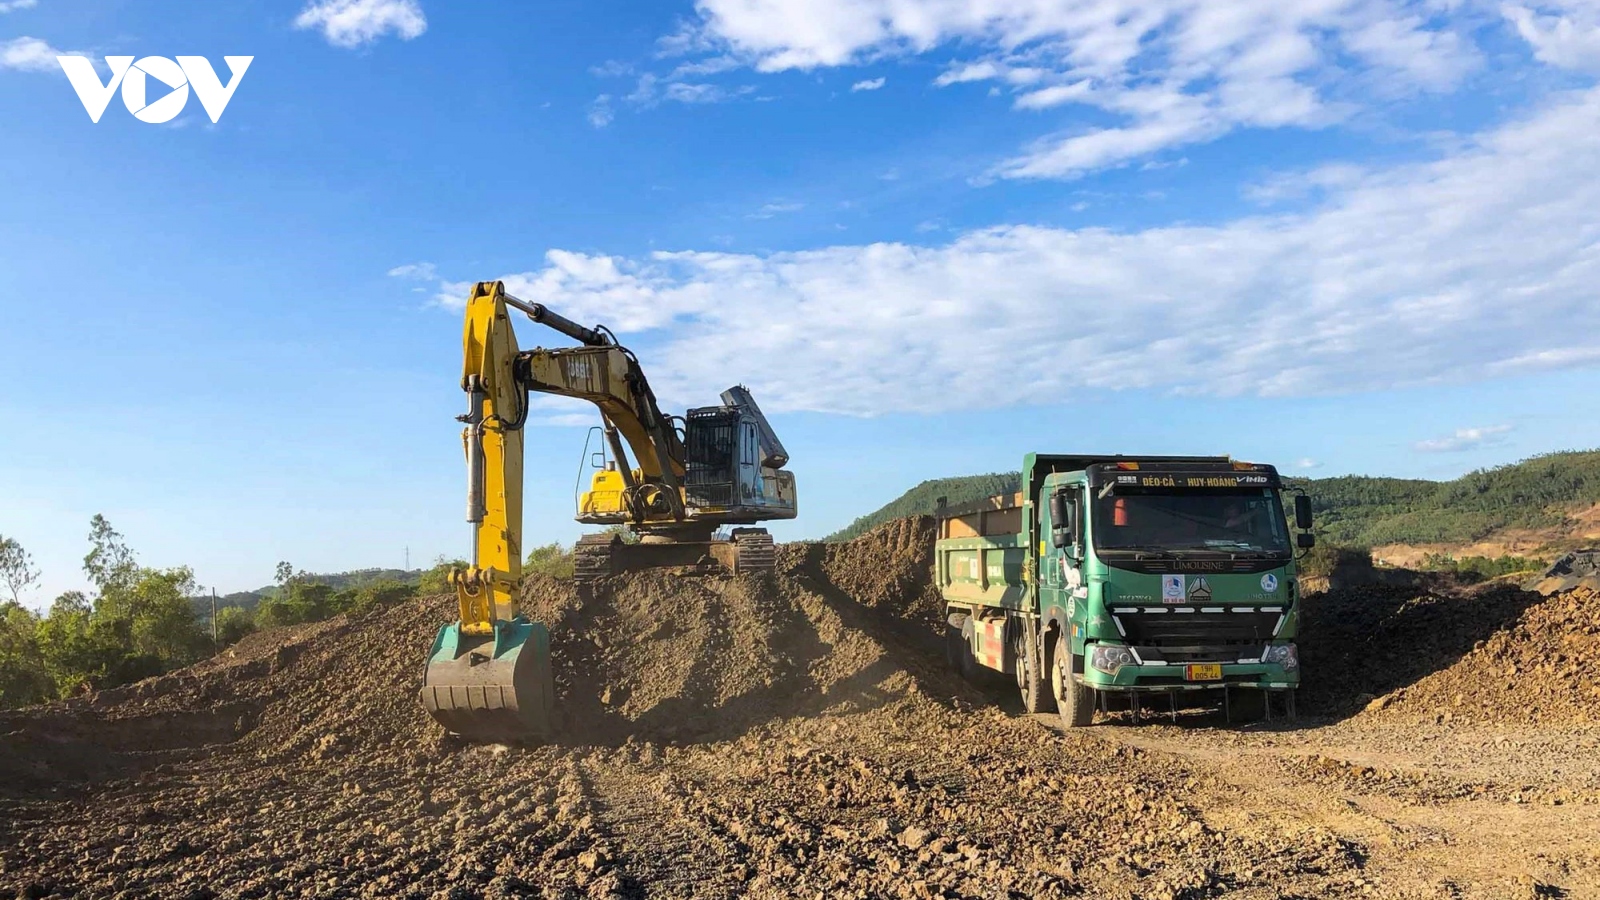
[{"left": 523, "top": 572, "right": 940, "bottom": 743}]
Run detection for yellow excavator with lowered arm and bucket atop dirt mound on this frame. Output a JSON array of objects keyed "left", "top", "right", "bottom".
[{"left": 422, "top": 282, "right": 795, "bottom": 741}]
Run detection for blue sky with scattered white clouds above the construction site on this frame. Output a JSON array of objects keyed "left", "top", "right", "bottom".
[{"left": 0, "top": 0, "right": 1600, "bottom": 605}]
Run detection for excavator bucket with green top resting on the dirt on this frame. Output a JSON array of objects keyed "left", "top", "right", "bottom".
[{"left": 422, "top": 615, "right": 555, "bottom": 743}]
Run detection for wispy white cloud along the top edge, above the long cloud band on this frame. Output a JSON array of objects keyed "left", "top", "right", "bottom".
[{"left": 667, "top": 0, "right": 1478, "bottom": 178}]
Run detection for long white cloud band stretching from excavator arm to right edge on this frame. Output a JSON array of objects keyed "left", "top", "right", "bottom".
[{"left": 419, "top": 90, "right": 1600, "bottom": 415}]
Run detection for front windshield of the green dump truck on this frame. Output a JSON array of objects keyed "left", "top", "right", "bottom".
[{"left": 1093, "top": 488, "right": 1290, "bottom": 554}]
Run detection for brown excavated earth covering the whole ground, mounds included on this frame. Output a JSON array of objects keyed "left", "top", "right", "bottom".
[{"left": 0, "top": 519, "right": 1600, "bottom": 900}]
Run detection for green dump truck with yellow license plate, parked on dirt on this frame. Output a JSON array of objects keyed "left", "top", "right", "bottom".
[{"left": 934, "top": 453, "right": 1314, "bottom": 727}]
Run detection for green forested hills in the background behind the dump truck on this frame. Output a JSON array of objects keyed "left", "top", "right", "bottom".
[{"left": 827, "top": 450, "right": 1600, "bottom": 546}]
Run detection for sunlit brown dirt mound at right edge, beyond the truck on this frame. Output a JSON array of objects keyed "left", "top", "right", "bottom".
[{"left": 1370, "top": 588, "right": 1600, "bottom": 725}]
